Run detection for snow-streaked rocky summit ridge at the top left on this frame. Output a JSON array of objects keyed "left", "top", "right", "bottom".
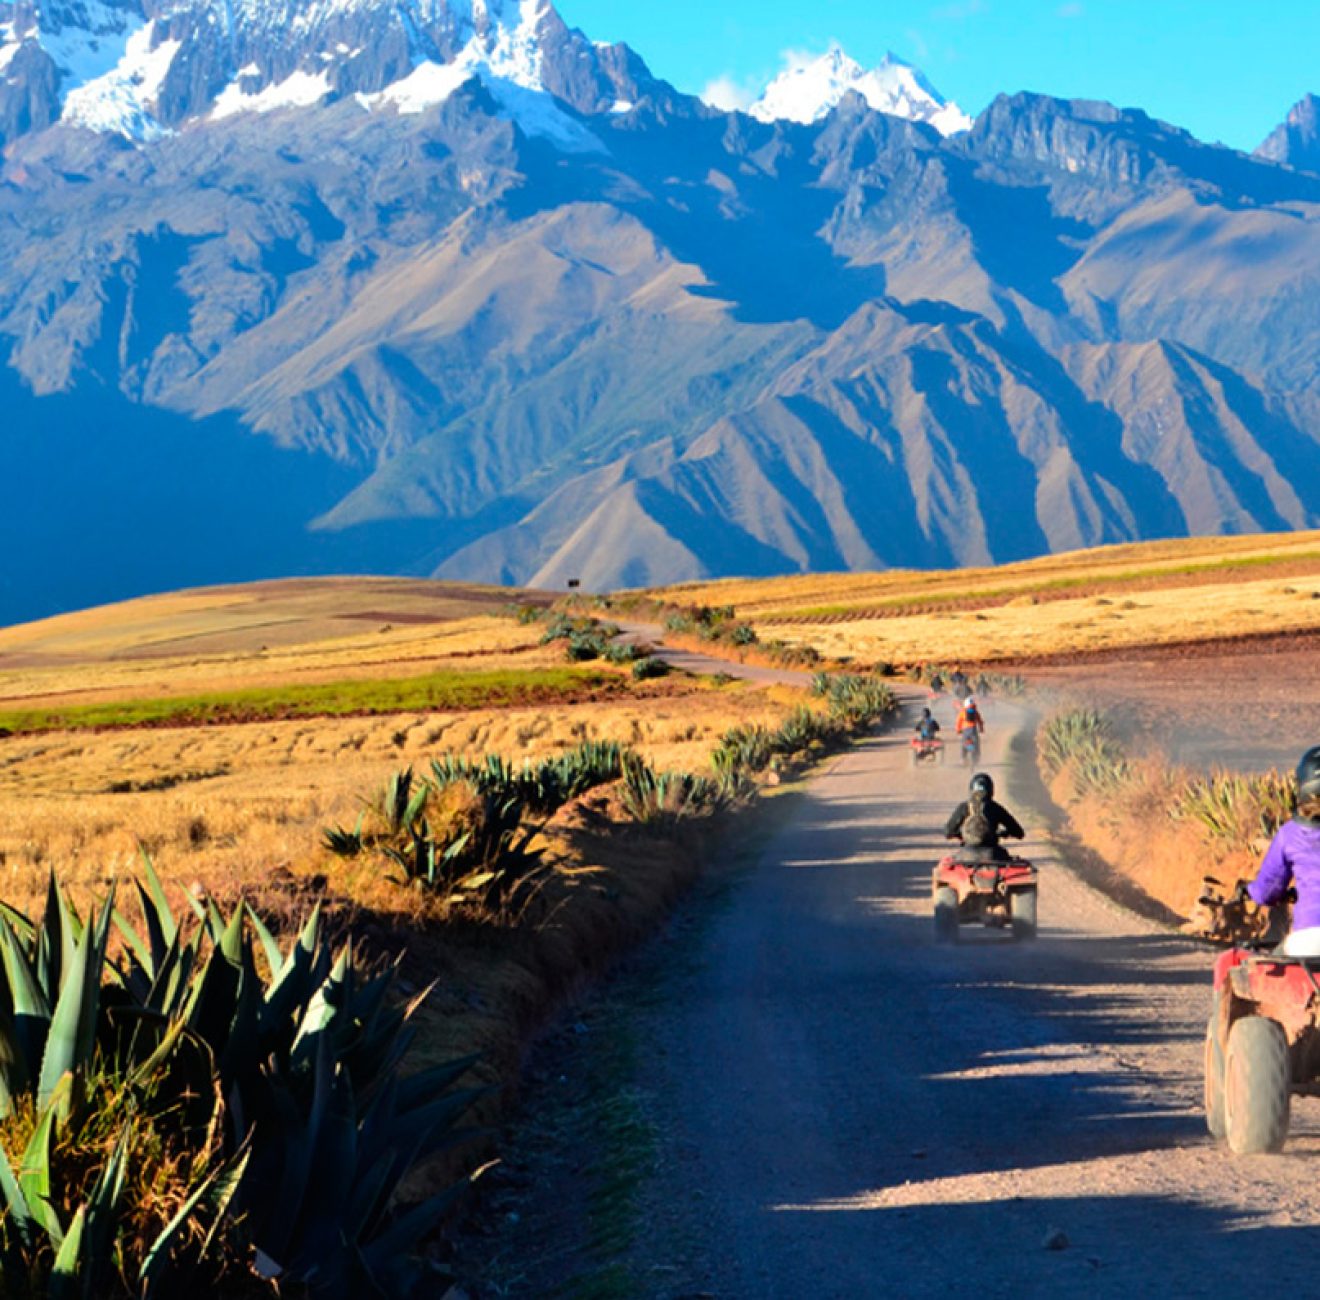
[{"left": 0, "top": 0, "right": 633, "bottom": 150}]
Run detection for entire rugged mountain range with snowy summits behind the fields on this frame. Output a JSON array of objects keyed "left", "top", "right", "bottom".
[{"left": 0, "top": 0, "right": 1320, "bottom": 620}]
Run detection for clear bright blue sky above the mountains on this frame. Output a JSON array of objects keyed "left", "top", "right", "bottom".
[{"left": 557, "top": 0, "right": 1320, "bottom": 149}]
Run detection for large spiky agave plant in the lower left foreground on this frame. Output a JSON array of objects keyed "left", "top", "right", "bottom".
[{"left": 0, "top": 861, "right": 477, "bottom": 1300}]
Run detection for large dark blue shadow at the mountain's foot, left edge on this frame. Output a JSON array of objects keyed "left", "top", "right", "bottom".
[{"left": 0, "top": 368, "right": 451, "bottom": 624}]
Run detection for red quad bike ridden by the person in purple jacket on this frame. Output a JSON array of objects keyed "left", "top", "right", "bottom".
[{"left": 1205, "top": 948, "right": 1320, "bottom": 1156}]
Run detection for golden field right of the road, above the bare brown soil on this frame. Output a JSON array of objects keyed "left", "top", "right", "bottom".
[{"left": 657, "top": 533, "right": 1320, "bottom": 663}]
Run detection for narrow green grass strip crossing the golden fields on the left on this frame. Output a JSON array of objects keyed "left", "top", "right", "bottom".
[{"left": 0, "top": 666, "right": 612, "bottom": 735}]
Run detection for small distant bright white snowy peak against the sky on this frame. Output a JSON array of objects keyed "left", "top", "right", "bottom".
[{"left": 750, "top": 45, "right": 972, "bottom": 136}]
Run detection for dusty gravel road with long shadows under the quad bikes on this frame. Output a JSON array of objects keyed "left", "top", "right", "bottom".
[{"left": 620, "top": 696, "right": 1320, "bottom": 1297}]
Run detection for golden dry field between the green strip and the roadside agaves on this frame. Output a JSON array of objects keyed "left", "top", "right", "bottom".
[{"left": 0, "top": 684, "right": 787, "bottom": 905}]
